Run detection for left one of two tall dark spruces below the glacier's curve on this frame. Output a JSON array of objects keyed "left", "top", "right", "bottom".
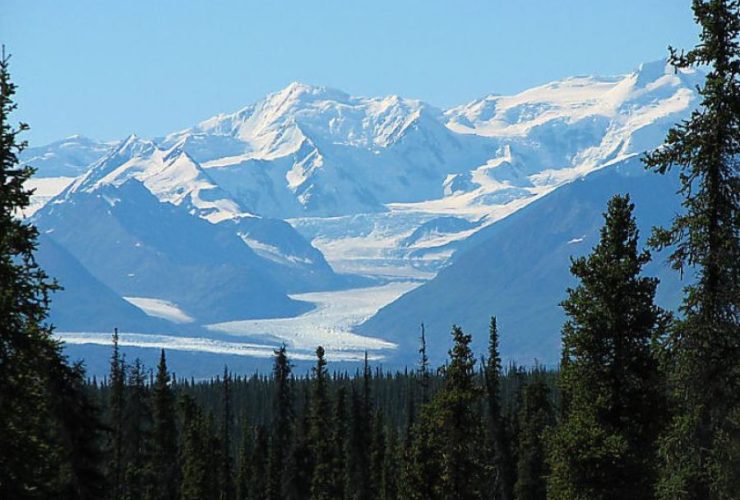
[{"left": 269, "top": 344, "right": 294, "bottom": 500}]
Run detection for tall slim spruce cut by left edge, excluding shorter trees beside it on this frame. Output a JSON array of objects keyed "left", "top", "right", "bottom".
[{"left": 0, "top": 47, "right": 61, "bottom": 498}]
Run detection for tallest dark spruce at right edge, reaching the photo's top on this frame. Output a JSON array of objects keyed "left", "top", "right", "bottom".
[{"left": 645, "top": 0, "right": 740, "bottom": 499}]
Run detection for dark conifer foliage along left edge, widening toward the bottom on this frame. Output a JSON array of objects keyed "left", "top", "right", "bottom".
[{"left": 0, "top": 47, "right": 105, "bottom": 499}]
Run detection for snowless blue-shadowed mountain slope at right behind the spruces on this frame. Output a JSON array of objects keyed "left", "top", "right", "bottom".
[{"left": 356, "top": 158, "right": 685, "bottom": 365}]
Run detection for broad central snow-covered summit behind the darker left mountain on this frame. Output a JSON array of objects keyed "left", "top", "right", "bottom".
[{"left": 161, "top": 83, "right": 492, "bottom": 218}]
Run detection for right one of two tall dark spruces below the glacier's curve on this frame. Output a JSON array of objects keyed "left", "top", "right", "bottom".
[{"left": 309, "top": 346, "right": 333, "bottom": 500}]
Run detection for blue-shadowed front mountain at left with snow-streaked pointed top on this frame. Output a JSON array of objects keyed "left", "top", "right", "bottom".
[{"left": 34, "top": 136, "right": 356, "bottom": 328}]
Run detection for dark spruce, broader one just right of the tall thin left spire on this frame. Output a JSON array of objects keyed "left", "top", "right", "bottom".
[{"left": 149, "top": 349, "right": 179, "bottom": 500}]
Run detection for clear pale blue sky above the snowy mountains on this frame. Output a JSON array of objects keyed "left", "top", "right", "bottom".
[{"left": 0, "top": 0, "right": 697, "bottom": 145}]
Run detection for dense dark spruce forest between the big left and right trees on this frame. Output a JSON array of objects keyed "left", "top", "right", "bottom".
[{"left": 87, "top": 319, "right": 557, "bottom": 500}]
